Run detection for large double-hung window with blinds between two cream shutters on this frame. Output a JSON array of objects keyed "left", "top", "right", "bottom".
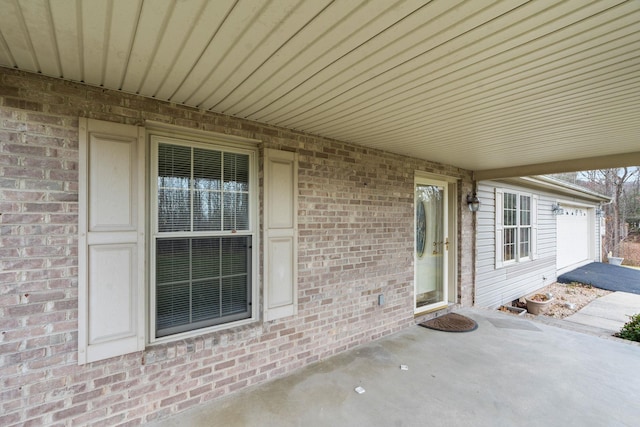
[{"left": 153, "top": 142, "right": 254, "bottom": 338}]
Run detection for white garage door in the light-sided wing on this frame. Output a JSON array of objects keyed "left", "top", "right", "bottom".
[{"left": 556, "top": 205, "right": 593, "bottom": 270}]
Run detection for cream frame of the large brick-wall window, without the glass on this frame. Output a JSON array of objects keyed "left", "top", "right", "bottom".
[{"left": 147, "top": 131, "right": 260, "bottom": 344}]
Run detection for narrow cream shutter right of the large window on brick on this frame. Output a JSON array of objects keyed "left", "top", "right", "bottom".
[{"left": 263, "top": 149, "right": 298, "bottom": 321}]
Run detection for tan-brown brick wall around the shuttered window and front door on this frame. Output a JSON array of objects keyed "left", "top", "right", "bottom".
[{"left": 0, "top": 68, "right": 474, "bottom": 426}]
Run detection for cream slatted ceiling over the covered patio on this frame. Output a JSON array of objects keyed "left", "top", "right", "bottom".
[{"left": 0, "top": 0, "right": 640, "bottom": 179}]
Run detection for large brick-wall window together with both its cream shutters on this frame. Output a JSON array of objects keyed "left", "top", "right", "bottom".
[{"left": 78, "top": 117, "right": 298, "bottom": 364}]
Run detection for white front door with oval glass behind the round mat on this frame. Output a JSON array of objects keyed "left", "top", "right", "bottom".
[{"left": 414, "top": 179, "right": 449, "bottom": 313}]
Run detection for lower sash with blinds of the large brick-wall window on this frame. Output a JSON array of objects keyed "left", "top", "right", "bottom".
[{"left": 156, "top": 236, "right": 251, "bottom": 337}]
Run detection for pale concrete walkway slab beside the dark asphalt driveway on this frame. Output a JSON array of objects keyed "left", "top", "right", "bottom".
[{"left": 564, "top": 292, "right": 640, "bottom": 334}]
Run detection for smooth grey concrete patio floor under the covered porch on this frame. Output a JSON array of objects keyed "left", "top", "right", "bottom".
[{"left": 153, "top": 309, "right": 640, "bottom": 427}]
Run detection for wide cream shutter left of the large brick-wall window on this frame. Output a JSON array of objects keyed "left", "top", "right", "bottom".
[{"left": 78, "top": 118, "right": 145, "bottom": 364}]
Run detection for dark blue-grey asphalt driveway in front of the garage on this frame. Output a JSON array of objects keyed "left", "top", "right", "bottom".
[{"left": 558, "top": 262, "right": 640, "bottom": 294}]
